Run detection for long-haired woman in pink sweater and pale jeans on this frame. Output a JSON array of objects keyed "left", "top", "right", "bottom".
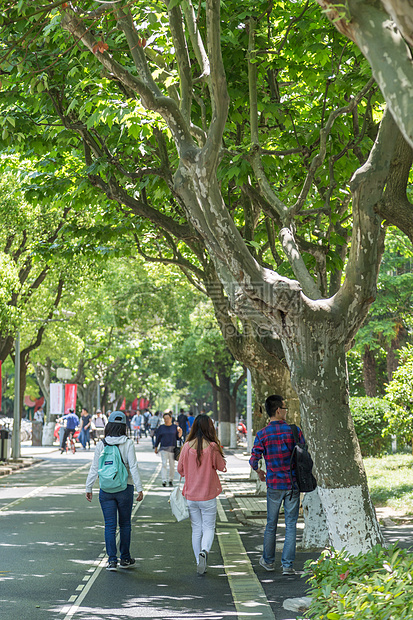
[{"left": 178, "top": 414, "right": 226, "bottom": 575}]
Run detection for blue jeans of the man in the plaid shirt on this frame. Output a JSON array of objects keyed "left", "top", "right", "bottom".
[{"left": 262, "top": 488, "right": 300, "bottom": 568}]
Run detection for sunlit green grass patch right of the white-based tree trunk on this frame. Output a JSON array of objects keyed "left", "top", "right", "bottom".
[{"left": 364, "top": 454, "right": 413, "bottom": 515}]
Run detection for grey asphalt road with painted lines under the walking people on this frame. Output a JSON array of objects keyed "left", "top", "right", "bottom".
[{"left": 0, "top": 440, "right": 308, "bottom": 620}]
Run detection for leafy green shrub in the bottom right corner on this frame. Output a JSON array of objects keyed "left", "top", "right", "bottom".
[{"left": 305, "top": 545, "right": 413, "bottom": 620}]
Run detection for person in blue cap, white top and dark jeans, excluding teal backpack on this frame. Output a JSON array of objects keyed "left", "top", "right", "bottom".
[{"left": 86, "top": 411, "right": 143, "bottom": 571}]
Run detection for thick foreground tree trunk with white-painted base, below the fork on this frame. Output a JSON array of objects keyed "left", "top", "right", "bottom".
[{"left": 285, "top": 320, "right": 383, "bottom": 555}]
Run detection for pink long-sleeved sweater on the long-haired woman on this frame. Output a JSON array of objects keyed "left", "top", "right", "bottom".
[{"left": 178, "top": 443, "right": 227, "bottom": 502}]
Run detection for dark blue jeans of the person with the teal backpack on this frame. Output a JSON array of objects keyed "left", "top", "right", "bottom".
[{"left": 99, "top": 484, "right": 133, "bottom": 562}]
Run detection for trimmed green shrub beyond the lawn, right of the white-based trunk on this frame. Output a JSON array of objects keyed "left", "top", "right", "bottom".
[{"left": 350, "top": 397, "right": 391, "bottom": 456}]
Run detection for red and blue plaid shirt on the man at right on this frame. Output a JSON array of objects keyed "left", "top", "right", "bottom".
[{"left": 250, "top": 420, "right": 304, "bottom": 489}]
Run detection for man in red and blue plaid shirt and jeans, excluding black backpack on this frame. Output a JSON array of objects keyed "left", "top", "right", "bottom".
[{"left": 250, "top": 394, "right": 304, "bottom": 575}]
